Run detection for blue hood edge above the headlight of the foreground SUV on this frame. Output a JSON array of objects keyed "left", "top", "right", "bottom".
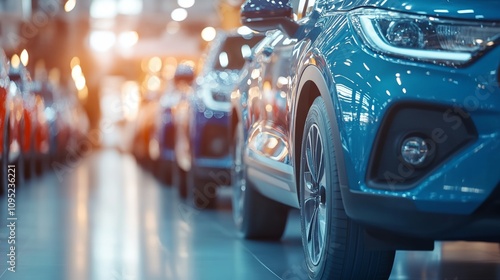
[{"left": 326, "top": 0, "right": 500, "bottom": 21}]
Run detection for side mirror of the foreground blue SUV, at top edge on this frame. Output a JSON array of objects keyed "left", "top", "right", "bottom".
[{"left": 240, "top": 0, "right": 299, "bottom": 37}]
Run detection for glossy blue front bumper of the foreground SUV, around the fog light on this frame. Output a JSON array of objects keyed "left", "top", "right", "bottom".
[{"left": 326, "top": 17, "right": 500, "bottom": 240}]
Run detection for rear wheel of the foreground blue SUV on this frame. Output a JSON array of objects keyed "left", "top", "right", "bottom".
[{"left": 231, "top": 124, "right": 288, "bottom": 240}]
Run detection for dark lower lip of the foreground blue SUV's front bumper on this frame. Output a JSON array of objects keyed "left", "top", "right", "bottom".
[{"left": 342, "top": 185, "right": 500, "bottom": 242}]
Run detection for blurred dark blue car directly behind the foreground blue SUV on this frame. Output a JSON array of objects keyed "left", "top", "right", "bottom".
[{"left": 176, "top": 31, "right": 263, "bottom": 208}]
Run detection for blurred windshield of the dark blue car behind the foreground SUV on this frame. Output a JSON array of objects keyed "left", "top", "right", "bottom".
[{"left": 214, "top": 35, "right": 263, "bottom": 71}]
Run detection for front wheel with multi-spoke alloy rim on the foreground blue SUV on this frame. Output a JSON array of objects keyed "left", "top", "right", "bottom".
[{"left": 299, "top": 97, "right": 395, "bottom": 280}]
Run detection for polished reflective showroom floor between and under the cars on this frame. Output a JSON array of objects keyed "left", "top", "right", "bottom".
[{"left": 0, "top": 150, "right": 500, "bottom": 280}]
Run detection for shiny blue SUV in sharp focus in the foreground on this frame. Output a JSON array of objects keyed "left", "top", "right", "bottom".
[{"left": 231, "top": 0, "right": 500, "bottom": 279}]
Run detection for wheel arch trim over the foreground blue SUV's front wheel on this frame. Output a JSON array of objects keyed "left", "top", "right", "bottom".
[{"left": 292, "top": 63, "right": 347, "bottom": 203}]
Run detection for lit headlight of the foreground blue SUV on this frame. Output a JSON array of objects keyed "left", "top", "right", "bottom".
[{"left": 349, "top": 9, "right": 500, "bottom": 65}]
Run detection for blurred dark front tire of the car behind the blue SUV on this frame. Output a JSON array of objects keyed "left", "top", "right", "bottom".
[{"left": 187, "top": 165, "right": 218, "bottom": 209}]
